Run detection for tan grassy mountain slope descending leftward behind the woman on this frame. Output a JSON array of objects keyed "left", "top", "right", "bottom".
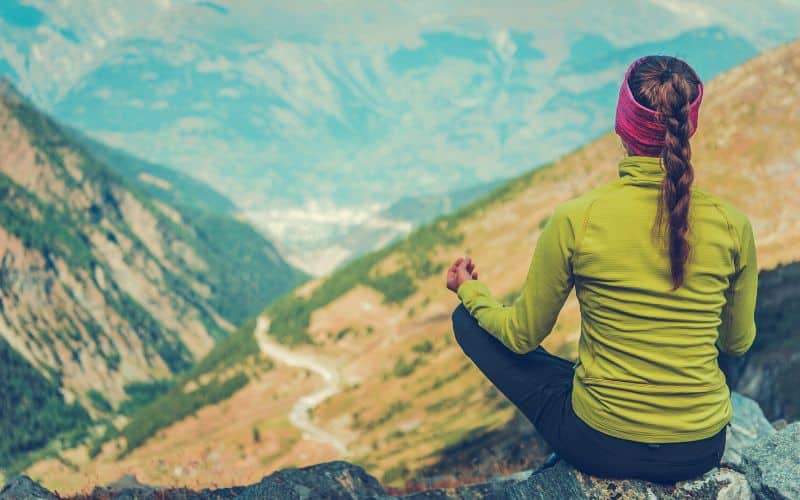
[{"left": 20, "top": 37, "right": 800, "bottom": 491}]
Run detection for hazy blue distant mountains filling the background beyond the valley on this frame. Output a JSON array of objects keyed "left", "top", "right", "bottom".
[{"left": 0, "top": 0, "right": 800, "bottom": 262}]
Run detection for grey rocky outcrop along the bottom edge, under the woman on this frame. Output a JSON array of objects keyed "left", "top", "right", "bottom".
[{"left": 0, "top": 393, "right": 800, "bottom": 500}]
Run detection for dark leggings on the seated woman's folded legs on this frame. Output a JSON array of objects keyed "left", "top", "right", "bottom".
[{"left": 453, "top": 304, "right": 725, "bottom": 483}]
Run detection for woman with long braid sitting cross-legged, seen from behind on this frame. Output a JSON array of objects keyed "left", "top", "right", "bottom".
[{"left": 447, "top": 56, "right": 758, "bottom": 482}]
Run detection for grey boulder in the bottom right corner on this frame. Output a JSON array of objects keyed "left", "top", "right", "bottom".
[{"left": 742, "top": 422, "right": 800, "bottom": 500}]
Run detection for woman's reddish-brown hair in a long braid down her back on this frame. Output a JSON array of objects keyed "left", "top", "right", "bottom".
[{"left": 628, "top": 56, "right": 700, "bottom": 290}]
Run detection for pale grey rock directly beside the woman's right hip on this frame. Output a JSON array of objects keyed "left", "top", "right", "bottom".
[{"left": 722, "top": 392, "right": 775, "bottom": 470}]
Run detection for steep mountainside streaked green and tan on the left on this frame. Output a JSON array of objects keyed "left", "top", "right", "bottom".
[{"left": 0, "top": 80, "right": 304, "bottom": 467}]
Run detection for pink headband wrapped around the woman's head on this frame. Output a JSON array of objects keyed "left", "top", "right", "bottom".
[{"left": 614, "top": 57, "right": 703, "bottom": 156}]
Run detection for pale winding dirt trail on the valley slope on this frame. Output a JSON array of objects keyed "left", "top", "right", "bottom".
[{"left": 255, "top": 316, "right": 347, "bottom": 455}]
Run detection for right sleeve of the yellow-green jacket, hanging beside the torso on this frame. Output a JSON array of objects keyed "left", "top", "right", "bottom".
[{"left": 717, "top": 221, "right": 758, "bottom": 356}]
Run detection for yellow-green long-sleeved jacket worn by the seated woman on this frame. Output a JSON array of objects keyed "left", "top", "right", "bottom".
[{"left": 457, "top": 156, "right": 758, "bottom": 443}]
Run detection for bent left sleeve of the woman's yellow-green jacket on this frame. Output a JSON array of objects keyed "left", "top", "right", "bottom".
[{"left": 457, "top": 205, "right": 575, "bottom": 354}]
